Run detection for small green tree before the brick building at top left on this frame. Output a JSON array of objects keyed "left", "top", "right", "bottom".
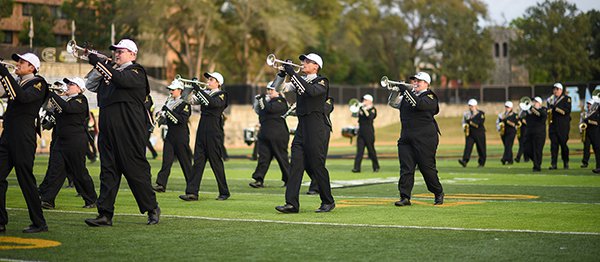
[{"left": 19, "top": 5, "right": 56, "bottom": 47}]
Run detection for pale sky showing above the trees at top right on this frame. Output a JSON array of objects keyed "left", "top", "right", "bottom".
[{"left": 482, "top": 0, "right": 600, "bottom": 25}]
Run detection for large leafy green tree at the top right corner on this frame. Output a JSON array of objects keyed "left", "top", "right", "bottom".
[{"left": 511, "top": 0, "right": 594, "bottom": 82}]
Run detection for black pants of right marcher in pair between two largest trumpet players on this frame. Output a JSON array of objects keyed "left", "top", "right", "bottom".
[{"left": 185, "top": 131, "right": 230, "bottom": 196}]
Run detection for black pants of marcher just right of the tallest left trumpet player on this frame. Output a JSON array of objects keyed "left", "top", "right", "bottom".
[{"left": 156, "top": 135, "right": 192, "bottom": 188}]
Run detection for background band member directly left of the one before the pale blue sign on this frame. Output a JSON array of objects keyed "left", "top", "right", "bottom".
[{"left": 525, "top": 96, "right": 548, "bottom": 172}]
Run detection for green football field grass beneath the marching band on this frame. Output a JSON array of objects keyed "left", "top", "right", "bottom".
[{"left": 0, "top": 144, "right": 600, "bottom": 261}]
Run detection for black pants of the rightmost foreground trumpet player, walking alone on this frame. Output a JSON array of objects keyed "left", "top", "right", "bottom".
[{"left": 398, "top": 129, "right": 444, "bottom": 199}]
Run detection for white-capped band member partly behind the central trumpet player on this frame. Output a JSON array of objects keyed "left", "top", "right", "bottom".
[{"left": 249, "top": 82, "right": 290, "bottom": 188}]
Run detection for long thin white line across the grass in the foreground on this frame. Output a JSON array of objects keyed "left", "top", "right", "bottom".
[{"left": 7, "top": 208, "right": 600, "bottom": 236}]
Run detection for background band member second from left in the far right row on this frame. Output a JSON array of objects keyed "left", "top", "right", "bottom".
[{"left": 496, "top": 101, "right": 519, "bottom": 165}]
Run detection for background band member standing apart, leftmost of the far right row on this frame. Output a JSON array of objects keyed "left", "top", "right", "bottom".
[{"left": 458, "top": 99, "right": 486, "bottom": 167}]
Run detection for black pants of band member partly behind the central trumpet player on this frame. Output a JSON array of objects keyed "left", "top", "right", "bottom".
[{"left": 252, "top": 133, "right": 290, "bottom": 183}]
